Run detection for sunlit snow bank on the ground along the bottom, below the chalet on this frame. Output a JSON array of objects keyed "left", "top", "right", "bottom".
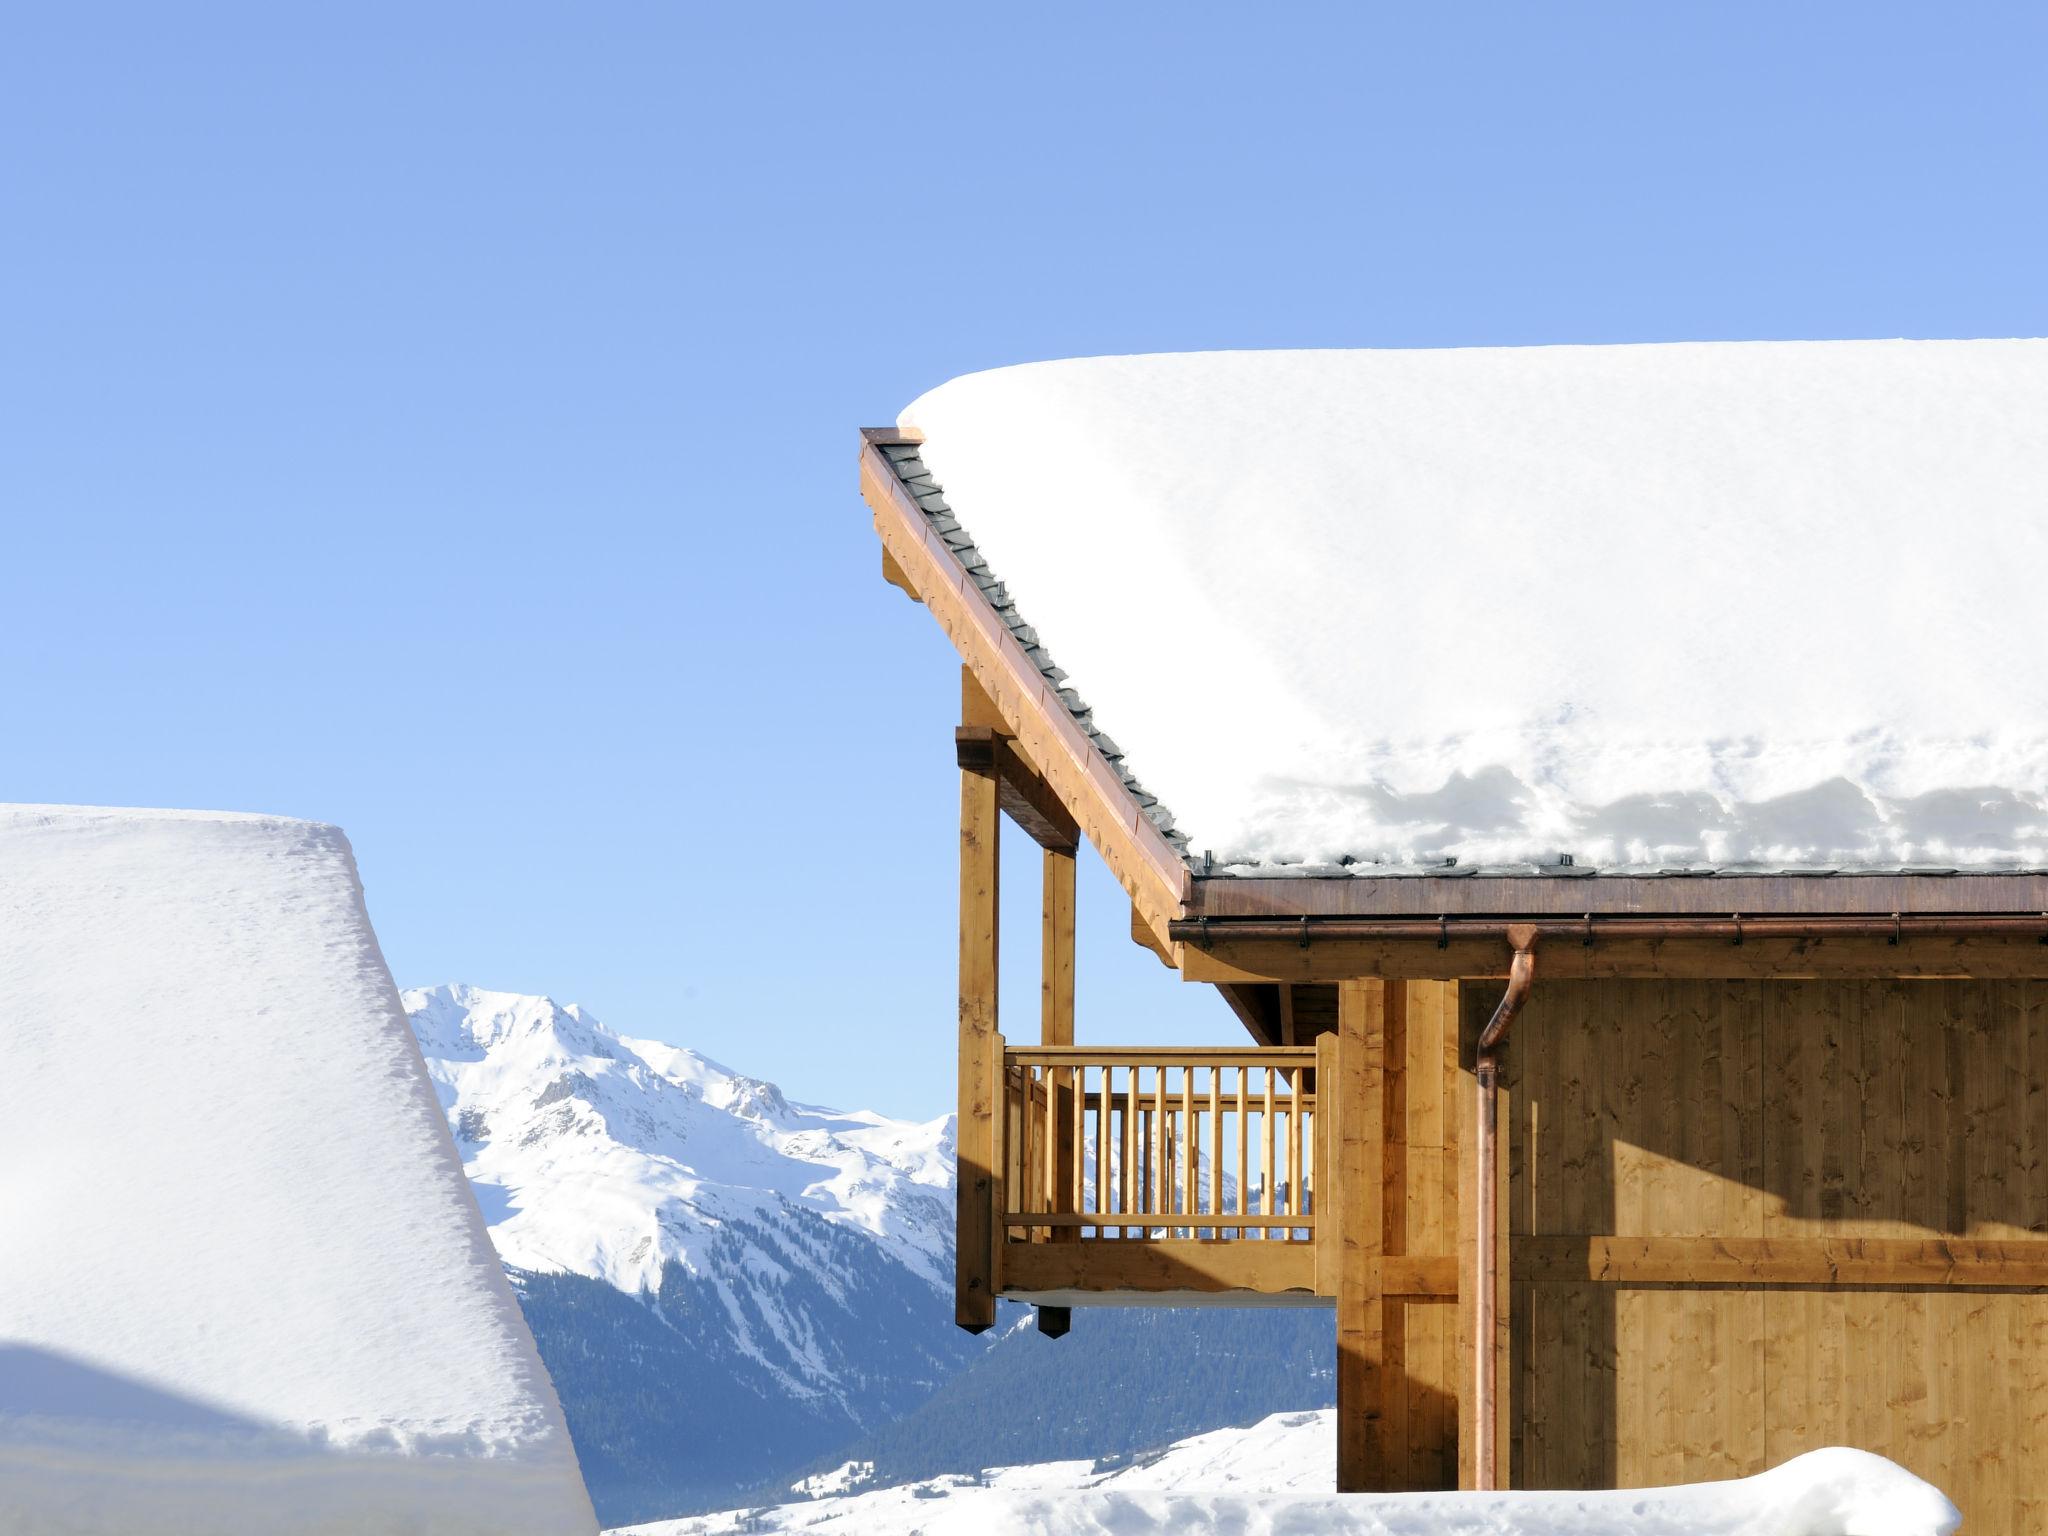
[{"left": 614, "top": 1409, "right": 1962, "bottom": 1536}]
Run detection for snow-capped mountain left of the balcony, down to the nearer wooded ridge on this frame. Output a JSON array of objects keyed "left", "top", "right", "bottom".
[{"left": 403, "top": 985, "right": 981, "bottom": 1518}]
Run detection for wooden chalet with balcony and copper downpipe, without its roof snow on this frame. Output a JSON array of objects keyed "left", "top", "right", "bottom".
[{"left": 860, "top": 342, "right": 2048, "bottom": 1536}]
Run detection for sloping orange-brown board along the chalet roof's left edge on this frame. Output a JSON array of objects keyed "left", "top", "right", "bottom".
[{"left": 860, "top": 428, "right": 1192, "bottom": 961}]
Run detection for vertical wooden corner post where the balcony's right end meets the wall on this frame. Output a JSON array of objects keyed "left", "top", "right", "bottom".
[{"left": 1329, "top": 981, "right": 1401, "bottom": 1493}]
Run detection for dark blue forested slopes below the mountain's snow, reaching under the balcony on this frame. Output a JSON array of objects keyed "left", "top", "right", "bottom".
[{"left": 514, "top": 1210, "right": 1335, "bottom": 1526}]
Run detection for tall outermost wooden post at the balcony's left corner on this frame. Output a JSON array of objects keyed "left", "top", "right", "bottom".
[{"left": 952, "top": 753, "right": 1001, "bottom": 1333}]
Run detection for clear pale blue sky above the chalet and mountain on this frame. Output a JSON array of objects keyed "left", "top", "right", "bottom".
[{"left": 0, "top": 4, "right": 2048, "bottom": 1114}]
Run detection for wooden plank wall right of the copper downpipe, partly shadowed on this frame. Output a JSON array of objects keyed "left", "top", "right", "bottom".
[{"left": 1499, "top": 979, "right": 2048, "bottom": 1536}]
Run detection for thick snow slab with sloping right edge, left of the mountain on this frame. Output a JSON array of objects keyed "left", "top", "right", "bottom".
[{"left": 0, "top": 807, "right": 596, "bottom": 1536}]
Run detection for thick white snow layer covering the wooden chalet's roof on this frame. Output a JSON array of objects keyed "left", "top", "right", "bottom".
[{"left": 901, "top": 340, "right": 2048, "bottom": 872}]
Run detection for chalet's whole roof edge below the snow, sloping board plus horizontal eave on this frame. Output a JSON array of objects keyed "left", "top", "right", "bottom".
[{"left": 860, "top": 428, "right": 2048, "bottom": 991}]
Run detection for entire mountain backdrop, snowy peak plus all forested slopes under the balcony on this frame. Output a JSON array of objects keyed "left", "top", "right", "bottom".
[{"left": 406, "top": 987, "right": 1333, "bottom": 1524}]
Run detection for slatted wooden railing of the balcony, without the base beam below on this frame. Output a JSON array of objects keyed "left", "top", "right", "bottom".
[{"left": 995, "top": 1047, "right": 1323, "bottom": 1243}]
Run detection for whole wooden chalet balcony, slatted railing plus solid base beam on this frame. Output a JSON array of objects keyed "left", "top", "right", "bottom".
[{"left": 969, "top": 1036, "right": 1333, "bottom": 1307}]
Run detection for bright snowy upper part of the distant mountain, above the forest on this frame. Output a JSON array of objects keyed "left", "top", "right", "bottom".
[{"left": 406, "top": 985, "right": 952, "bottom": 1290}]
